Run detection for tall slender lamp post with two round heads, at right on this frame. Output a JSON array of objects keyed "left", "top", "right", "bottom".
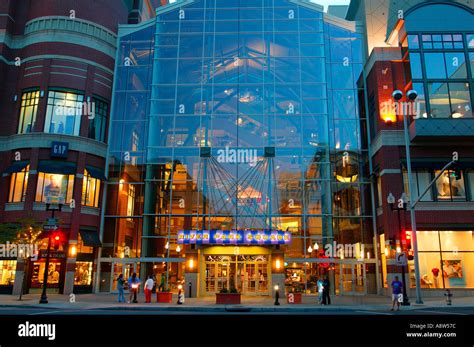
[{"left": 392, "top": 90, "right": 423, "bottom": 304}]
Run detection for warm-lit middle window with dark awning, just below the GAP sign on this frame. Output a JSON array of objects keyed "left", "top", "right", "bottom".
[{"left": 35, "top": 172, "right": 74, "bottom": 204}]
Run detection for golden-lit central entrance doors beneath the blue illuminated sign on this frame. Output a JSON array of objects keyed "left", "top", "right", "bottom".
[{"left": 205, "top": 255, "right": 269, "bottom": 295}]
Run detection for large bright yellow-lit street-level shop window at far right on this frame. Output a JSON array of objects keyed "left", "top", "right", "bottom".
[{"left": 417, "top": 231, "right": 474, "bottom": 288}]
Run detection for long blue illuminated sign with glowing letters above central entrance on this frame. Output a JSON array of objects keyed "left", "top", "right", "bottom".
[{"left": 178, "top": 230, "right": 291, "bottom": 245}]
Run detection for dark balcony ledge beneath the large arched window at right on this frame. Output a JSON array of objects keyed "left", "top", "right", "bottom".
[{"left": 410, "top": 118, "right": 474, "bottom": 142}]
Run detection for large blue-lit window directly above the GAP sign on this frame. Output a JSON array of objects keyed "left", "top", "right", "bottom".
[{"left": 44, "top": 91, "right": 84, "bottom": 136}]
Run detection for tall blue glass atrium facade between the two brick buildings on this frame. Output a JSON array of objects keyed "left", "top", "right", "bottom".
[{"left": 100, "top": 0, "right": 375, "bottom": 295}]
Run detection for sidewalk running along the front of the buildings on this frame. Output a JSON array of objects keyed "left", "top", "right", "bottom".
[{"left": 0, "top": 293, "right": 474, "bottom": 312}]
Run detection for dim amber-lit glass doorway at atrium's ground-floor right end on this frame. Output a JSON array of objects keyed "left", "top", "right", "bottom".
[{"left": 336, "top": 263, "right": 367, "bottom": 295}]
